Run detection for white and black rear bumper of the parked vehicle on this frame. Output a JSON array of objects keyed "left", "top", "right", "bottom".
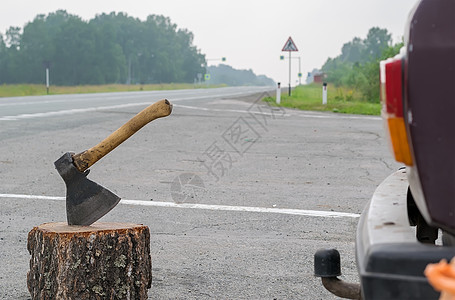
[{"left": 356, "top": 169, "right": 455, "bottom": 300}]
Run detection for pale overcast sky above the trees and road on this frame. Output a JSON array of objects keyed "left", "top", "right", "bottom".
[{"left": 0, "top": 0, "right": 417, "bottom": 85}]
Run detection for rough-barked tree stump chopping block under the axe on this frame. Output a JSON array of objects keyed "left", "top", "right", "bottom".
[{"left": 27, "top": 222, "right": 152, "bottom": 300}]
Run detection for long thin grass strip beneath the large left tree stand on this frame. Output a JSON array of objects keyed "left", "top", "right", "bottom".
[{"left": 0, "top": 83, "right": 227, "bottom": 97}]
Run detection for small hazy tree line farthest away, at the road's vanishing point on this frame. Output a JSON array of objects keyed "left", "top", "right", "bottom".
[{"left": 208, "top": 64, "right": 275, "bottom": 86}]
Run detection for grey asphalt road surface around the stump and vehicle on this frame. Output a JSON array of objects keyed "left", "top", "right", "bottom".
[{"left": 0, "top": 87, "right": 400, "bottom": 299}]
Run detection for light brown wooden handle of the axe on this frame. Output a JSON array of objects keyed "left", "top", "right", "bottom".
[{"left": 73, "top": 99, "right": 172, "bottom": 172}]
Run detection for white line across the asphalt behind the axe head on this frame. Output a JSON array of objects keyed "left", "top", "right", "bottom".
[{"left": 0, "top": 194, "right": 360, "bottom": 218}]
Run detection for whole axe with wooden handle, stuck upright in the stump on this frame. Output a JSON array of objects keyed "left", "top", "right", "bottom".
[{"left": 54, "top": 99, "right": 172, "bottom": 226}]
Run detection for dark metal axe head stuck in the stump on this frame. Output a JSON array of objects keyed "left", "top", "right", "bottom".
[{"left": 54, "top": 152, "right": 120, "bottom": 226}]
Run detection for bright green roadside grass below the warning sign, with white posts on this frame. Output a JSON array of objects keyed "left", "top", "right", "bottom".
[{"left": 264, "top": 84, "right": 381, "bottom": 115}]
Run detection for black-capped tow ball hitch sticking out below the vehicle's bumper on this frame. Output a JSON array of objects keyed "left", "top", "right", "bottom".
[{"left": 314, "top": 249, "right": 362, "bottom": 300}]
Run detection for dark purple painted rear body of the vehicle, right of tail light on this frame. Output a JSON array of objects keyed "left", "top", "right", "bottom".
[{"left": 404, "top": 0, "right": 455, "bottom": 234}]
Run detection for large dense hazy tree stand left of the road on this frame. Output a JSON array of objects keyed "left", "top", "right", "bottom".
[{"left": 0, "top": 10, "right": 206, "bottom": 85}]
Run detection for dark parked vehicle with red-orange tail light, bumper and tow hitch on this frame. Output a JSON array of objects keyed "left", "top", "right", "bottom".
[{"left": 315, "top": 0, "right": 455, "bottom": 300}]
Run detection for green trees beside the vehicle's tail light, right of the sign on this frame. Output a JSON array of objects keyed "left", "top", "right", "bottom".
[{"left": 321, "top": 27, "right": 403, "bottom": 102}]
